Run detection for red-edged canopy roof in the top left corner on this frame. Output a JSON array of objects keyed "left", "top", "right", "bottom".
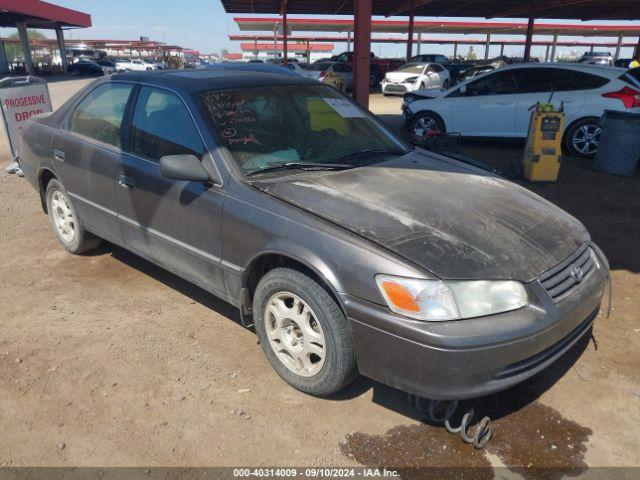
[{"left": 0, "top": 0, "right": 91, "bottom": 29}]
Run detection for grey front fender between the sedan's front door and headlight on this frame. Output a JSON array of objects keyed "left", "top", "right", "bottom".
[{"left": 222, "top": 180, "right": 425, "bottom": 304}]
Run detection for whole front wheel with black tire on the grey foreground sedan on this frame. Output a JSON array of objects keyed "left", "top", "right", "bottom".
[{"left": 253, "top": 268, "right": 358, "bottom": 396}]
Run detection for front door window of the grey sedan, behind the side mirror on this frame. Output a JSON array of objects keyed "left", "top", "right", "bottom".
[{"left": 130, "top": 87, "right": 205, "bottom": 162}]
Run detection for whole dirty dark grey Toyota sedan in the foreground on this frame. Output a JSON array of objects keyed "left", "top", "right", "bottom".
[{"left": 21, "top": 70, "right": 608, "bottom": 399}]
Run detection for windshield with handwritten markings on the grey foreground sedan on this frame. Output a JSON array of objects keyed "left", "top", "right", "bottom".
[{"left": 202, "top": 85, "right": 409, "bottom": 175}]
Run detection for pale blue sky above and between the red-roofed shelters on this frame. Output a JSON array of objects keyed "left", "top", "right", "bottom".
[{"left": 5, "top": 0, "right": 640, "bottom": 57}]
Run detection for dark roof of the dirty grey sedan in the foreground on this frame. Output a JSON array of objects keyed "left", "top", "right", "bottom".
[{"left": 110, "top": 68, "right": 318, "bottom": 93}]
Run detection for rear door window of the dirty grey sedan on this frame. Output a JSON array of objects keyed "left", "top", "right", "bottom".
[{"left": 68, "top": 83, "right": 133, "bottom": 147}]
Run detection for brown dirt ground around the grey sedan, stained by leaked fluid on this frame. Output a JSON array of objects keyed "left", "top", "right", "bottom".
[{"left": 0, "top": 81, "right": 640, "bottom": 478}]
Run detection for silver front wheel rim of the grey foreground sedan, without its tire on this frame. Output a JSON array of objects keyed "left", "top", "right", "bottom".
[{"left": 264, "top": 292, "right": 326, "bottom": 377}]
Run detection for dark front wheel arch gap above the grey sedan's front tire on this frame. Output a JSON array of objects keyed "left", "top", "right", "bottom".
[{"left": 242, "top": 253, "right": 346, "bottom": 315}]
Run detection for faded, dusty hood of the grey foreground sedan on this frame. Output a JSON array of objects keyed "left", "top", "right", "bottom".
[{"left": 255, "top": 149, "right": 589, "bottom": 282}]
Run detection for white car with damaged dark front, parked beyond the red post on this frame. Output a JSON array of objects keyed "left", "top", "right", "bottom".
[{"left": 380, "top": 63, "right": 451, "bottom": 95}]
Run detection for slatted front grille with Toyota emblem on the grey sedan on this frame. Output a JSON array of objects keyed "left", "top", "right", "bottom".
[{"left": 540, "top": 245, "right": 597, "bottom": 302}]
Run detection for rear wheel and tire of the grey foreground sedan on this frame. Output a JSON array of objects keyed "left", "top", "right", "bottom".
[{"left": 46, "top": 179, "right": 100, "bottom": 255}]
